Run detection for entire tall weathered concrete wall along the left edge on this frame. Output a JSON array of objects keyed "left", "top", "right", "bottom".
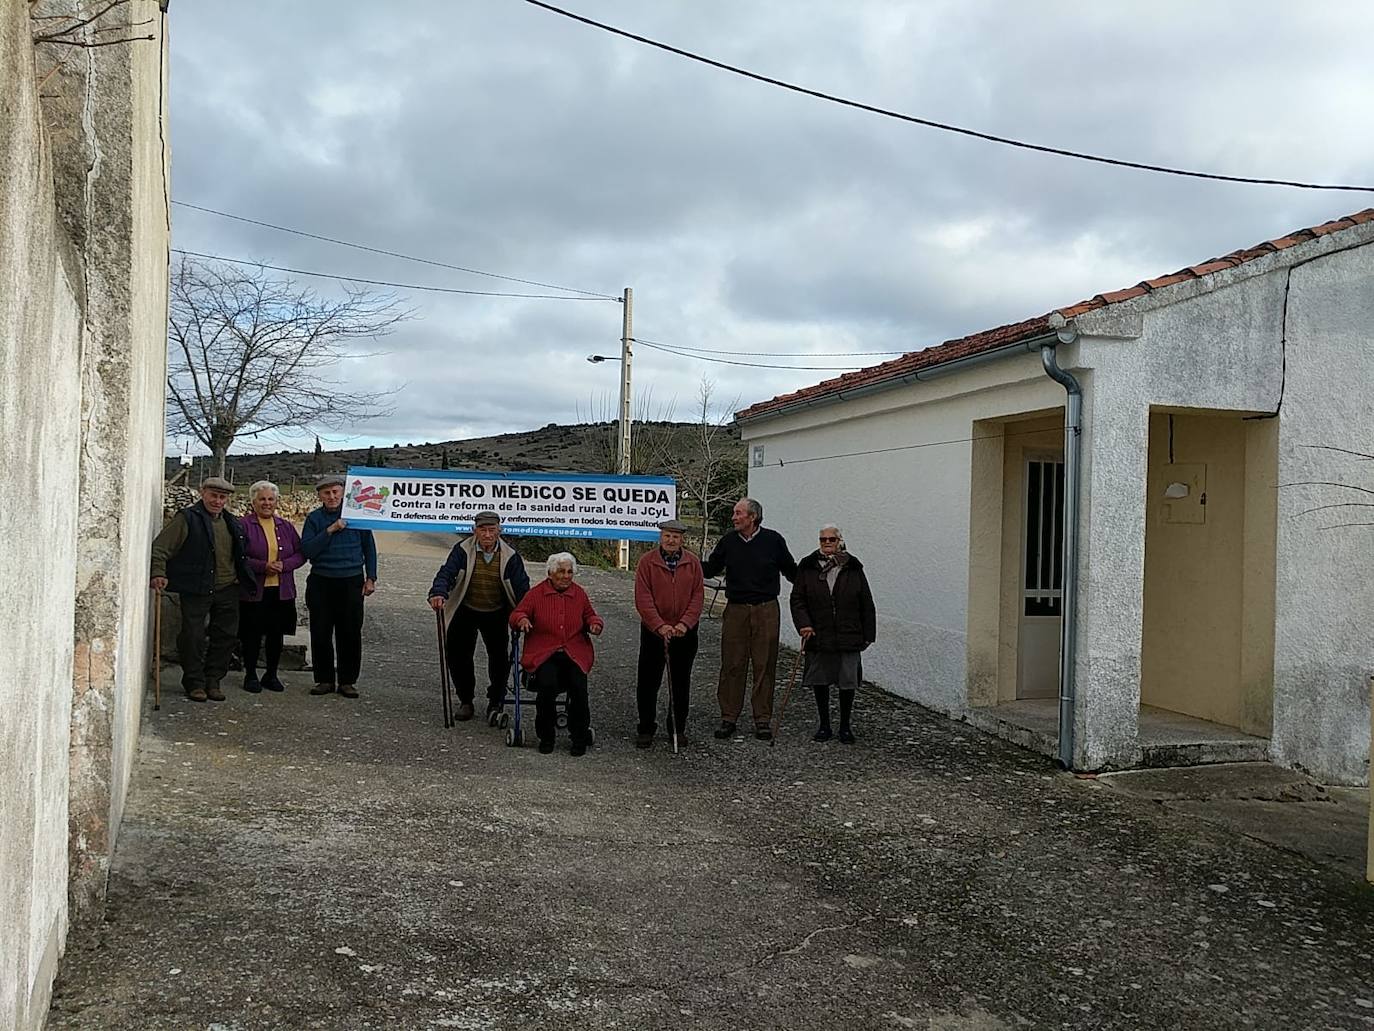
[{"left": 0, "top": 0, "right": 168, "bottom": 1028}]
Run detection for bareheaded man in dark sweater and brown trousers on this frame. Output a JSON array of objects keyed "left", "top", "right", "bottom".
[{"left": 702, "top": 498, "right": 797, "bottom": 741}]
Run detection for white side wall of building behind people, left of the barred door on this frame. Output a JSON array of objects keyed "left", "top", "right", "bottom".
[{"left": 745, "top": 355, "right": 1063, "bottom": 713}]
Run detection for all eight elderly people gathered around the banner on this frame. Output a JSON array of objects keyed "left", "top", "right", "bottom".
[{"left": 151, "top": 476, "right": 877, "bottom": 756}]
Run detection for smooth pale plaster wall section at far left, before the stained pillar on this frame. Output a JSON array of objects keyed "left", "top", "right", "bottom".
[{"left": 0, "top": 4, "right": 81, "bottom": 1028}]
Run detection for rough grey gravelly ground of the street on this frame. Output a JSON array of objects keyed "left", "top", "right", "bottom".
[{"left": 48, "top": 535, "right": 1374, "bottom": 1031}]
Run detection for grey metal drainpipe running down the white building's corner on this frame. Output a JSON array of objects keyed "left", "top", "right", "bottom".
[{"left": 1040, "top": 312, "right": 1083, "bottom": 770}]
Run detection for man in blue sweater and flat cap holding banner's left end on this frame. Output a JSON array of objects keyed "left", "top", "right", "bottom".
[{"left": 301, "top": 476, "right": 376, "bottom": 698}]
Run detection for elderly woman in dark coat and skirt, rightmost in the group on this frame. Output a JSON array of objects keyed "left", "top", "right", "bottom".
[{"left": 791, "top": 526, "right": 878, "bottom": 745}]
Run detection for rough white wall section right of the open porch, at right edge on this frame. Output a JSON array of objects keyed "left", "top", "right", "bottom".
[{"left": 1272, "top": 241, "right": 1374, "bottom": 784}]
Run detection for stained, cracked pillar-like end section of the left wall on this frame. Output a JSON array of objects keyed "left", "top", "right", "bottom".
[{"left": 60, "top": 0, "right": 168, "bottom": 922}]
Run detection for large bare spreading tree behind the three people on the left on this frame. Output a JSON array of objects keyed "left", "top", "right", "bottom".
[{"left": 168, "top": 257, "right": 411, "bottom": 476}]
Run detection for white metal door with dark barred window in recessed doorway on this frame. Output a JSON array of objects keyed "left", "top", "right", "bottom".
[{"left": 1017, "top": 452, "right": 1063, "bottom": 698}]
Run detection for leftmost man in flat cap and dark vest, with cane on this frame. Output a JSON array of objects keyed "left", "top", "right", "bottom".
[{"left": 150, "top": 476, "right": 254, "bottom": 701}]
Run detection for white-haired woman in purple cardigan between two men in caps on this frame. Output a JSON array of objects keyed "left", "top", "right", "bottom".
[{"left": 239, "top": 480, "right": 305, "bottom": 694}]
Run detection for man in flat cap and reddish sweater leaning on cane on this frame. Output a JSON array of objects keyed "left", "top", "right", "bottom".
[{"left": 635, "top": 520, "right": 705, "bottom": 748}]
